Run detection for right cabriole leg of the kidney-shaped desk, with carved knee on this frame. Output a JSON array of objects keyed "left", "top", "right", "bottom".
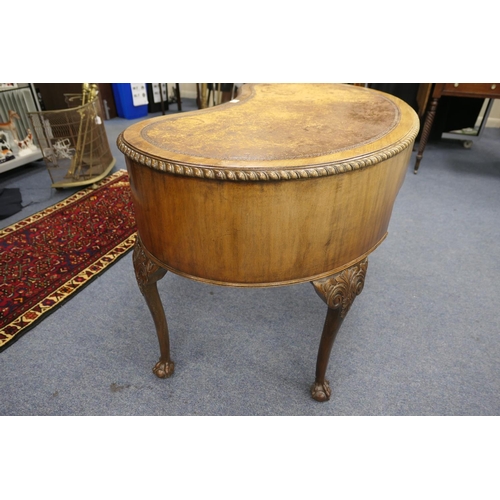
[{"left": 311, "top": 259, "right": 368, "bottom": 402}]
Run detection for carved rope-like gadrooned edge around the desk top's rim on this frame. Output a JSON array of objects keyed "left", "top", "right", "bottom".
[{"left": 117, "top": 125, "right": 419, "bottom": 182}]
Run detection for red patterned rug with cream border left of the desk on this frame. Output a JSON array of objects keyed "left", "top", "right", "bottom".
[{"left": 0, "top": 170, "right": 136, "bottom": 352}]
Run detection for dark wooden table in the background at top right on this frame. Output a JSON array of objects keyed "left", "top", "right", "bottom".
[{"left": 414, "top": 83, "right": 500, "bottom": 174}]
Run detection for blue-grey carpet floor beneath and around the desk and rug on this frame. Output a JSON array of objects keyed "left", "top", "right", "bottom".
[{"left": 0, "top": 99, "right": 500, "bottom": 416}]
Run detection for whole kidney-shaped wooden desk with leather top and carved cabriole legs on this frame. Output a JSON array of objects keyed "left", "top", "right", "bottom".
[{"left": 118, "top": 84, "right": 419, "bottom": 401}]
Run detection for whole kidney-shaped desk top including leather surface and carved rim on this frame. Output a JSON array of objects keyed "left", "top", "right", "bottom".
[{"left": 118, "top": 84, "right": 418, "bottom": 180}]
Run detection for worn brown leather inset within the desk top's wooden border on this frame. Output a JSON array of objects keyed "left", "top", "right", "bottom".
[{"left": 141, "top": 84, "right": 399, "bottom": 161}]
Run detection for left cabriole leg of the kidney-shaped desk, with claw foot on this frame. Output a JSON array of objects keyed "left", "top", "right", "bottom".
[{"left": 133, "top": 235, "right": 174, "bottom": 378}]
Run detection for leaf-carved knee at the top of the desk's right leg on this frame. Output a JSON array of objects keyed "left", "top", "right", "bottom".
[{"left": 312, "top": 259, "right": 368, "bottom": 318}]
